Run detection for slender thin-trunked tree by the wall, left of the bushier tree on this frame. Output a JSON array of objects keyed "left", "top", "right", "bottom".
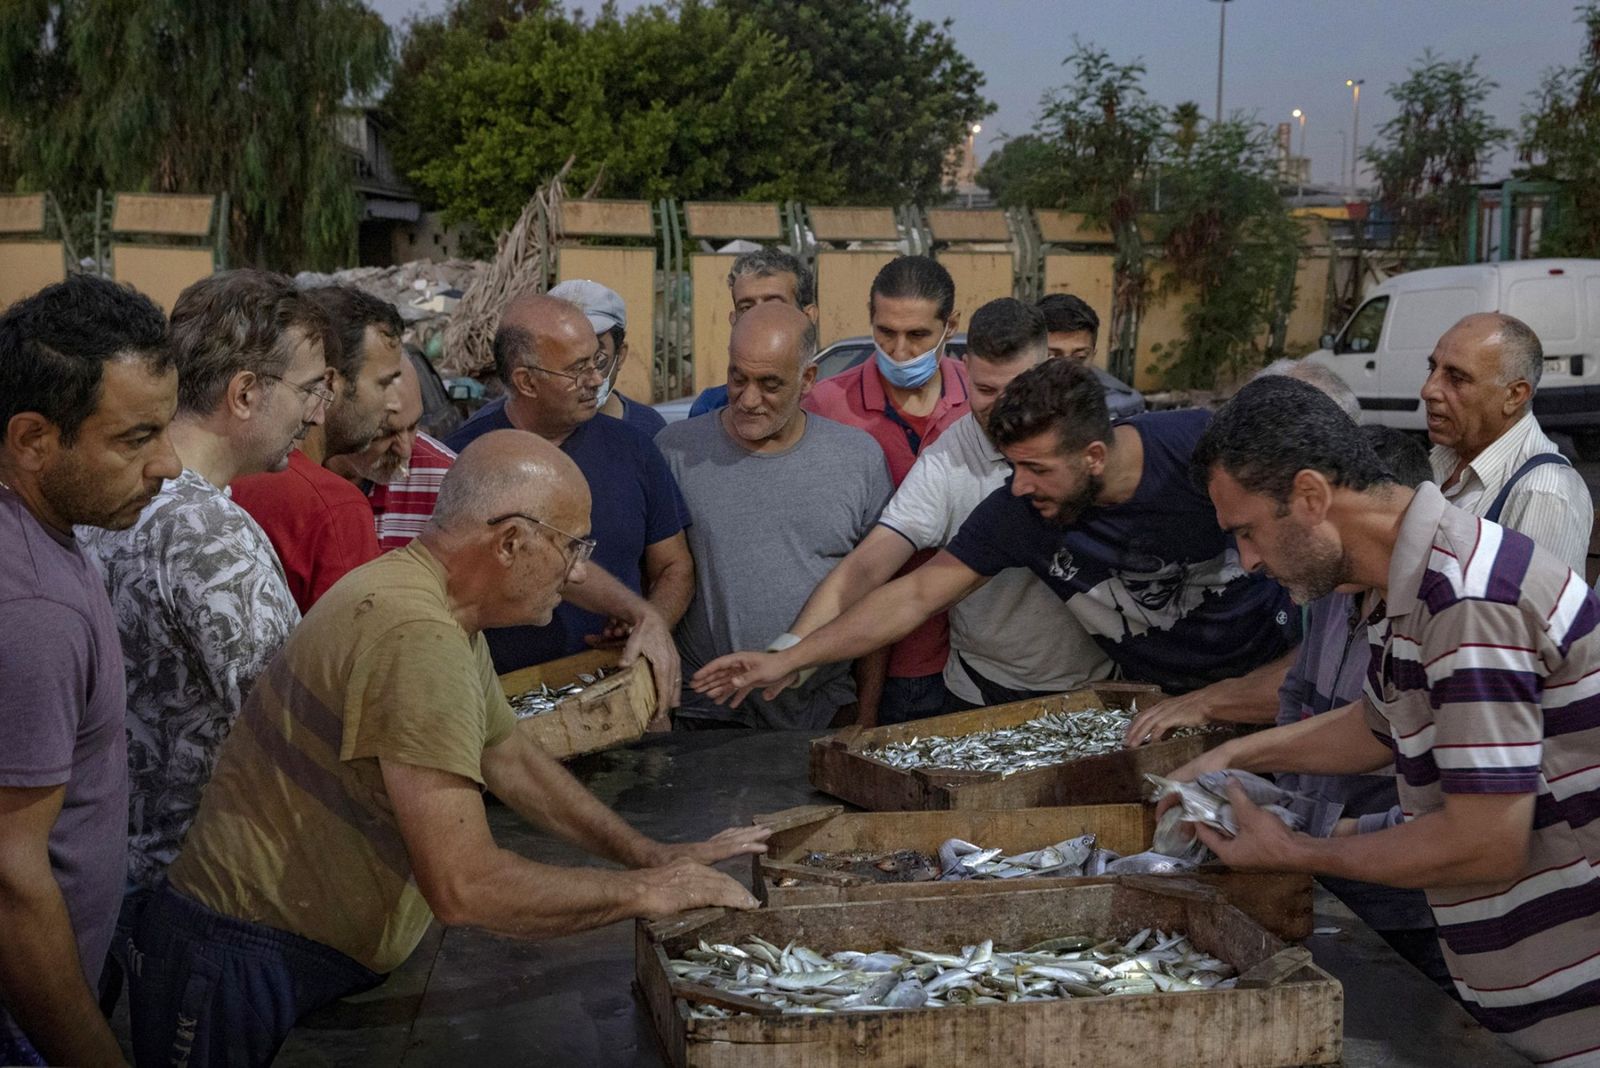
[{"left": 1027, "top": 43, "right": 1166, "bottom": 381}]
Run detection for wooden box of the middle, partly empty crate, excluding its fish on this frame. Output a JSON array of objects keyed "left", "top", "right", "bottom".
[{"left": 750, "top": 804, "right": 1312, "bottom": 942}]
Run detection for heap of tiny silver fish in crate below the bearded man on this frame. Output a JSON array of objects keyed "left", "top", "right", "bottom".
[{"left": 862, "top": 707, "right": 1195, "bottom": 775}]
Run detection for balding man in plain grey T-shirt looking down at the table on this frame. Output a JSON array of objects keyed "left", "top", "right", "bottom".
[{"left": 658, "top": 302, "right": 890, "bottom": 729}]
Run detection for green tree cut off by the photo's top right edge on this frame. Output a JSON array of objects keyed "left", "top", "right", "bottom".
[{"left": 1517, "top": 0, "right": 1600, "bottom": 256}]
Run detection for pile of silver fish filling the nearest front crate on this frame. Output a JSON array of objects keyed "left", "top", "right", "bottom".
[{"left": 669, "top": 929, "right": 1235, "bottom": 1020}]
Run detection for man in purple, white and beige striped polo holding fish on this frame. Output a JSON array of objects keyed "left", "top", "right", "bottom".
[{"left": 1174, "top": 377, "right": 1600, "bottom": 1065}]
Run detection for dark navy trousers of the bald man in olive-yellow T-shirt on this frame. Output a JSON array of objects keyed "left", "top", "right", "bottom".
[{"left": 128, "top": 886, "right": 382, "bottom": 1068}]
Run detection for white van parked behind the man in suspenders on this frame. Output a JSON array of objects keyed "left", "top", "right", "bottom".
[{"left": 1307, "top": 259, "right": 1600, "bottom": 452}]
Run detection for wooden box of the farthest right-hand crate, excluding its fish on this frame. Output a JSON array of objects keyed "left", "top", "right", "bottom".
[{"left": 811, "top": 683, "right": 1230, "bottom": 812}]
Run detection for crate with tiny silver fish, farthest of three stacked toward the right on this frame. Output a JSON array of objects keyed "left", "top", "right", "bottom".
[{"left": 811, "top": 683, "right": 1230, "bottom": 811}]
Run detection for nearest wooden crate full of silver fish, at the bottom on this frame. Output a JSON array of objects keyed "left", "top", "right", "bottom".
[{"left": 635, "top": 881, "right": 1344, "bottom": 1068}]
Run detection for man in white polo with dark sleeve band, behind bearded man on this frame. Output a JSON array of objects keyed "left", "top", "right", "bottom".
[{"left": 768, "top": 297, "right": 1112, "bottom": 726}]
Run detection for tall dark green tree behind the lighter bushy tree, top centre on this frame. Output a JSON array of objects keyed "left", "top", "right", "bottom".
[{"left": 722, "top": 0, "right": 995, "bottom": 205}]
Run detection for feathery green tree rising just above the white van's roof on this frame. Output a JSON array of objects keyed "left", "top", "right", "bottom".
[{"left": 1362, "top": 51, "right": 1512, "bottom": 264}]
